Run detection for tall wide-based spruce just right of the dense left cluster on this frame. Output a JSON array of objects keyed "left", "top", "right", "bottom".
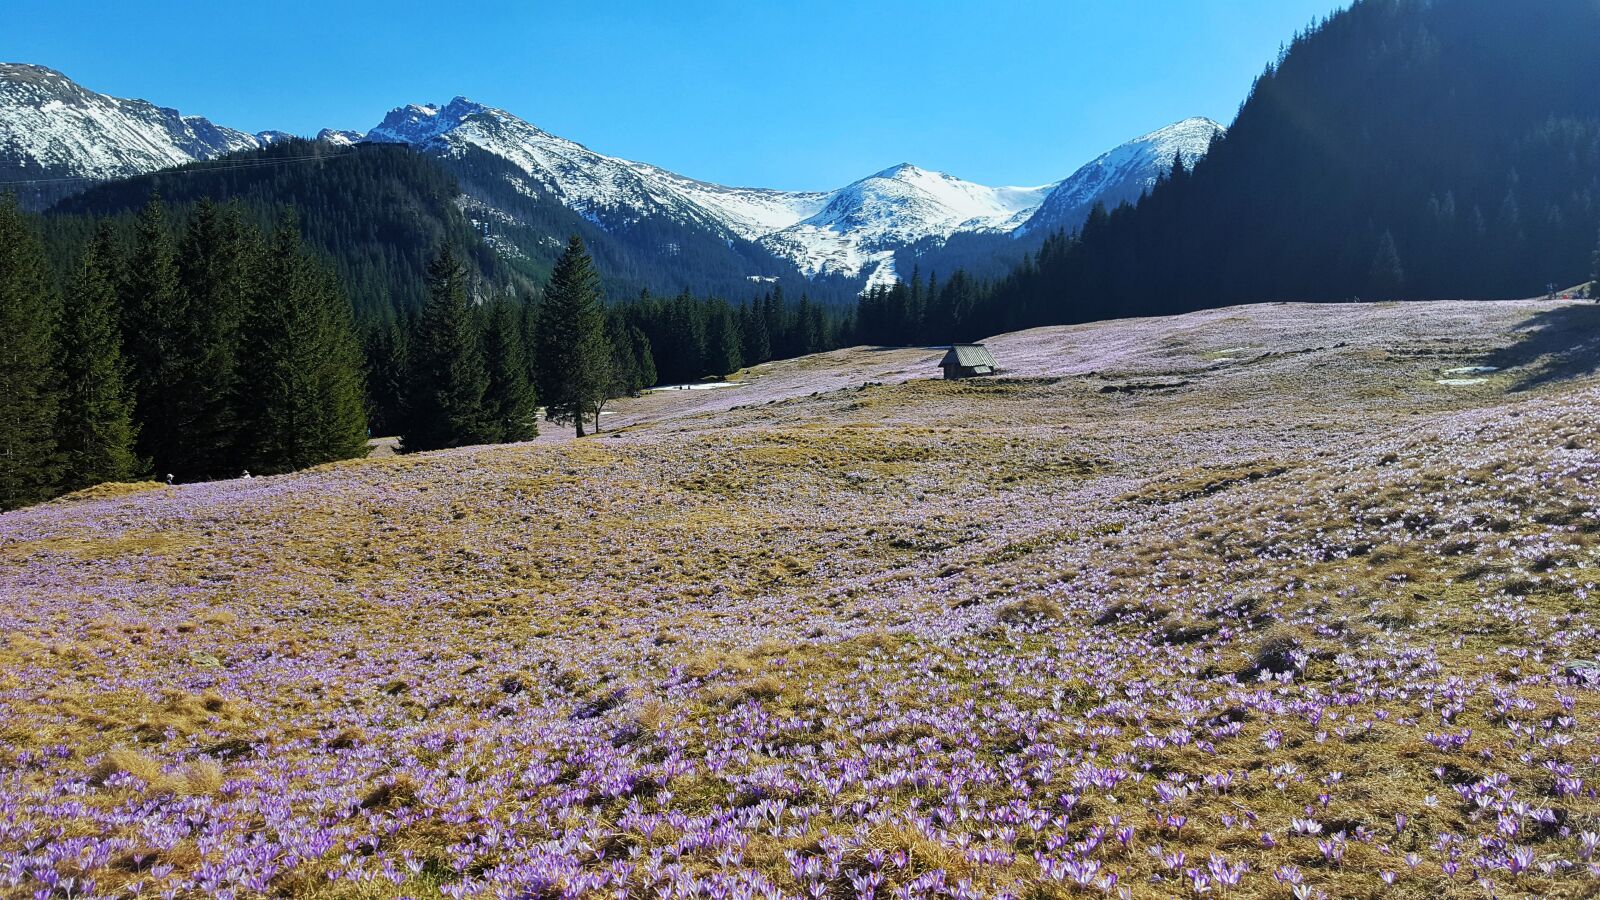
[{"left": 402, "top": 243, "right": 494, "bottom": 452}]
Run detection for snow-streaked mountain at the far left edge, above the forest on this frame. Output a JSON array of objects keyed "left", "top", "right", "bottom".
[{"left": 0, "top": 62, "right": 262, "bottom": 179}]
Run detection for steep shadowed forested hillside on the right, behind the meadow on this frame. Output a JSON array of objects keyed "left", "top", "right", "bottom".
[{"left": 926, "top": 0, "right": 1600, "bottom": 335}]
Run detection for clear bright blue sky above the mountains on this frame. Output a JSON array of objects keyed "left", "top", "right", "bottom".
[{"left": 0, "top": 0, "right": 1346, "bottom": 189}]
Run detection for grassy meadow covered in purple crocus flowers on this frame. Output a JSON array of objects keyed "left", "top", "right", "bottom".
[{"left": 0, "top": 303, "right": 1600, "bottom": 900}]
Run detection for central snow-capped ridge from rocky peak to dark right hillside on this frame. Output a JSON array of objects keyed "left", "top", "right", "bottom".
[{"left": 356, "top": 98, "right": 1222, "bottom": 285}]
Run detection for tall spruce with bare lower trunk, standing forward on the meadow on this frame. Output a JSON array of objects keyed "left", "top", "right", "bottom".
[{"left": 536, "top": 235, "right": 613, "bottom": 437}]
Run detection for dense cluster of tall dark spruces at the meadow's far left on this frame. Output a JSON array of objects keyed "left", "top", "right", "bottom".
[{"left": 0, "top": 192, "right": 366, "bottom": 508}]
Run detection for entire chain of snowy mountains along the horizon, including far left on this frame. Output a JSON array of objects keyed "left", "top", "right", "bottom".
[{"left": 0, "top": 64, "right": 1222, "bottom": 285}]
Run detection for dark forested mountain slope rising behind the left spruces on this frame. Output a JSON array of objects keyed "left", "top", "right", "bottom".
[{"left": 46, "top": 141, "right": 854, "bottom": 322}]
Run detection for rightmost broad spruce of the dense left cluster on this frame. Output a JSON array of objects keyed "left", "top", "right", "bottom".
[{"left": 237, "top": 216, "right": 366, "bottom": 474}]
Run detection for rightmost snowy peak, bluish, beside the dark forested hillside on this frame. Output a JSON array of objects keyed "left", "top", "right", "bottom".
[{"left": 1019, "top": 117, "right": 1227, "bottom": 234}]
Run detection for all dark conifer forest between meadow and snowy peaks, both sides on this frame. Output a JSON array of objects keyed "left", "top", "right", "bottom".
[{"left": 9, "top": 0, "right": 1600, "bottom": 506}]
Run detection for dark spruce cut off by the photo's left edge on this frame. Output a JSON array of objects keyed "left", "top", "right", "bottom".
[{"left": 0, "top": 197, "right": 58, "bottom": 509}]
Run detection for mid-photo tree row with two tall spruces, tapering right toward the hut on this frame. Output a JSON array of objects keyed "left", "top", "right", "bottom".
[{"left": 365, "top": 243, "right": 854, "bottom": 450}]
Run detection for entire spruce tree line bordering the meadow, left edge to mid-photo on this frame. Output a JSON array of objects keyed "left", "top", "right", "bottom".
[{"left": 0, "top": 189, "right": 854, "bottom": 509}]
